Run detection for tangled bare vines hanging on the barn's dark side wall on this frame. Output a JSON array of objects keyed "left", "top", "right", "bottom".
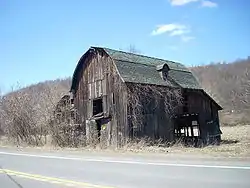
[{"left": 127, "top": 84, "right": 183, "bottom": 135}]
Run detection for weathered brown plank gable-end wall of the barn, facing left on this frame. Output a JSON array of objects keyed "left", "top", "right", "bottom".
[{"left": 74, "top": 51, "right": 127, "bottom": 145}]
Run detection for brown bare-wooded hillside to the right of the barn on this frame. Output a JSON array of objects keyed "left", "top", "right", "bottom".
[{"left": 191, "top": 57, "right": 250, "bottom": 124}]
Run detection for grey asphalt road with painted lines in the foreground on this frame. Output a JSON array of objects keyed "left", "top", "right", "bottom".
[{"left": 0, "top": 148, "right": 250, "bottom": 188}]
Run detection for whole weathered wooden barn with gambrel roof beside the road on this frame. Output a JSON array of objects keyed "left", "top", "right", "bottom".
[{"left": 71, "top": 47, "right": 222, "bottom": 145}]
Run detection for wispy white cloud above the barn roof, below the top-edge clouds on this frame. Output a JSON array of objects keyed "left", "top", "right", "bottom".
[{"left": 151, "top": 23, "right": 187, "bottom": 36}]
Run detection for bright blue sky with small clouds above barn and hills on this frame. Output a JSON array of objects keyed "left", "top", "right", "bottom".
[{"left": 0, "top": 0, "right": 250, "bottom": 92}]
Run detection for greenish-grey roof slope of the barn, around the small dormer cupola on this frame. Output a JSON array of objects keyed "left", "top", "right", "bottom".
[{"left": 103, "top": 48, "right": 201, "bottom": 89}]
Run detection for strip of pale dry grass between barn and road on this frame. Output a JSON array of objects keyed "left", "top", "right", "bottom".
[{"left": 0, "top": 125, "right": 250, "bottom": 158}]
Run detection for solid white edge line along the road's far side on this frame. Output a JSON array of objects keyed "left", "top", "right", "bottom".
[{"left": 0, "top": 151, "right": 250, "bottom": 170}]
